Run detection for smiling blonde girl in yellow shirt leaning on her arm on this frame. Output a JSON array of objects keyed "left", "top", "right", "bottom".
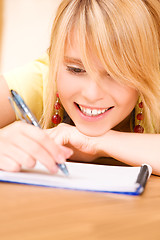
[{"left": 0, "top": 0, "right": 160, "bottom": 175}]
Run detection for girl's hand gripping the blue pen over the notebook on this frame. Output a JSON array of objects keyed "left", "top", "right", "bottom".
[{"left": 0, "top": 121, "right": 72, "bottom": 173}]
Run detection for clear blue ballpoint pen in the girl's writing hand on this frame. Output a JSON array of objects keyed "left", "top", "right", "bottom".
[{"left": 9, "top": 90, "right": 69, "bottom": 176}]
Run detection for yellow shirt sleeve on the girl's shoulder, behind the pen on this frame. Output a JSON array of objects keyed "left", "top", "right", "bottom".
[{"left": 4, "top": 54, "right": 49, "bottom": 120}]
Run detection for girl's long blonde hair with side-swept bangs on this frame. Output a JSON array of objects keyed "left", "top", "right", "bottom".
[{"left": 42, "top": 0, "right": 160, "bottom": 133}]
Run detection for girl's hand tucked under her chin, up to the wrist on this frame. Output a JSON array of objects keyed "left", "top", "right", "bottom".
[{"left": 47, "top": 123, "right": 99, "bottom": 162}]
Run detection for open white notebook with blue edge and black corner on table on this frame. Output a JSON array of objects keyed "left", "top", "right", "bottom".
[{"left": 0, "top": 162, "right": 152, "bottom": 195}]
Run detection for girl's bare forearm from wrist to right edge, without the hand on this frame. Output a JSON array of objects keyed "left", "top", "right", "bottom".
[{"left": 97, "top": 130, "right": 160, "bottom": 175}]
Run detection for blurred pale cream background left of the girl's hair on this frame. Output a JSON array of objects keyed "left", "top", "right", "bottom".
[{"left": 0, "top": 0, "right": 61, "bottom": 73}]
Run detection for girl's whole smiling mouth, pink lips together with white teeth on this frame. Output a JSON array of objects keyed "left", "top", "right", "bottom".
[{"left": 75, "top": 103, "right": 114, "bottom": 120}]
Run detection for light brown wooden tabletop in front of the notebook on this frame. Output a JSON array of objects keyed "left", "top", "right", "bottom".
[{"left": 0, "top": 158, "right": 160, "bottom": 240}]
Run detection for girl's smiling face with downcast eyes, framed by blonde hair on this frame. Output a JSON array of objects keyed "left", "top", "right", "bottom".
[{"left": 57, "top": 39, "right": 138, "bottom": 136}]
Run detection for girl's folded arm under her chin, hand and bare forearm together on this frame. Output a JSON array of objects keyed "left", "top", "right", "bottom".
[{"left": 47, "top": 124, "right": 160, "bottom": 175}]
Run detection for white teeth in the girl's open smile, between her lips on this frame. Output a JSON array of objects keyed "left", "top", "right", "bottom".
[{"left": 76, "top": 103, "right": 114, "bottom": 117}]
